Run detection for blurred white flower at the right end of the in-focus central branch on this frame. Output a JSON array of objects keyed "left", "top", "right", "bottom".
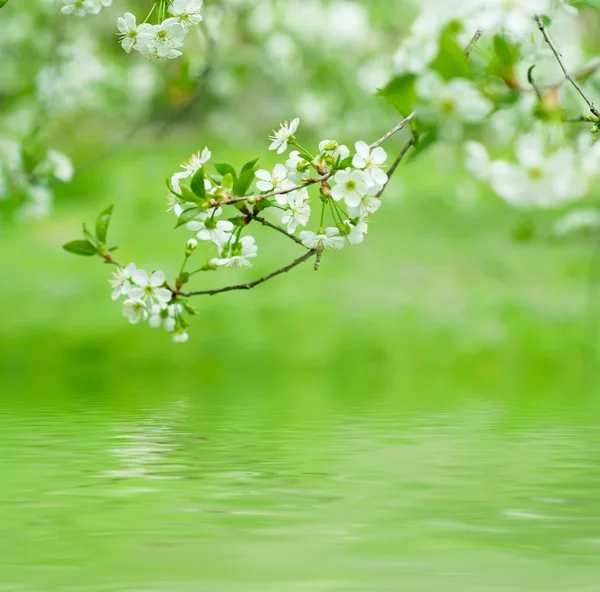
[{"left": 415, "top": 71, "right": 493, "bottom": 137}]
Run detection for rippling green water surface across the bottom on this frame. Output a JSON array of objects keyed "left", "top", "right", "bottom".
[{"left": 0, "top": 400, "right": 600, "bottom": 592}]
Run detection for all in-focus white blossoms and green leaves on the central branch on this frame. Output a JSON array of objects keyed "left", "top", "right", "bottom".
[{"left": 71, "top": 118, "right": 400, "bottom": 343}]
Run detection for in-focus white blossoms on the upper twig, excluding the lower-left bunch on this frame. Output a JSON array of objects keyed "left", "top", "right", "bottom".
[{"left": 167, "top": 118, "right": 388, "bottom": 269}]
